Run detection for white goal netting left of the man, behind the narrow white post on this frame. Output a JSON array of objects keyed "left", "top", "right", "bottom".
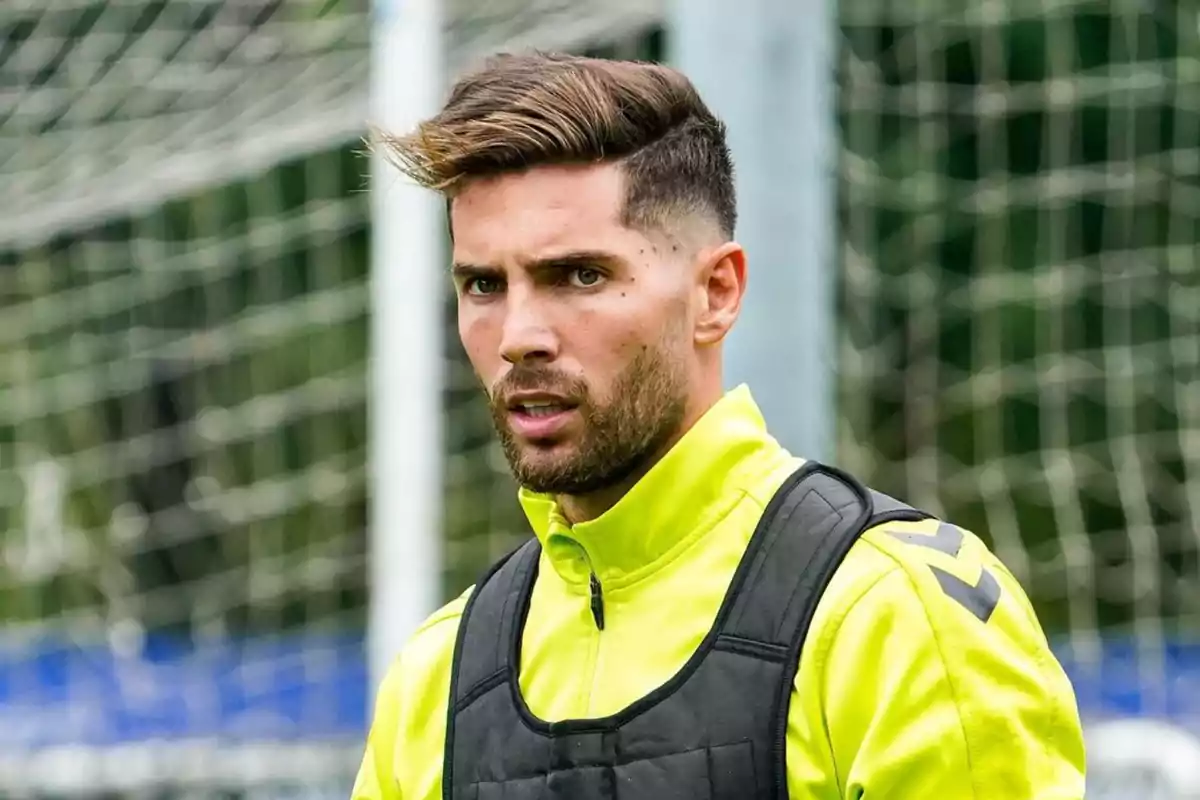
[{"left": 0, "top": 0, "right": 658, "bottom": 798}]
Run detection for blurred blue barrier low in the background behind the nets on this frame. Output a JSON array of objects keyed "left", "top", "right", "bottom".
[{"left": 0, "top": 636, "right": 1200, "bottom": 750}]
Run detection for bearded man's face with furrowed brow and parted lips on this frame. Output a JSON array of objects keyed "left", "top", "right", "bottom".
[{"left": 451, "top": 164, "right": 694, "bottom": 495}]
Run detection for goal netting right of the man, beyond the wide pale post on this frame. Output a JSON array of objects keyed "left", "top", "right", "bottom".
[{"left": 836, "top": 0, "right": 1200, "bottom": 730}]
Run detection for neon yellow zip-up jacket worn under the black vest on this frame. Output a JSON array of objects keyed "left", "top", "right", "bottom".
[{"left": 353, "top": 387, "right": 1085, "bottom": 800}]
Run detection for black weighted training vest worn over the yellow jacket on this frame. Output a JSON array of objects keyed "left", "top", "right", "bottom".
[{"left": 443, "top": 462, "right": 929, "bottom": 800}]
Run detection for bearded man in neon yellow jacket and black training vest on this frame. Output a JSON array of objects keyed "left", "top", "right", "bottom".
[{"left": 354, "top": 54, "right": 1084, "bottom": 800}]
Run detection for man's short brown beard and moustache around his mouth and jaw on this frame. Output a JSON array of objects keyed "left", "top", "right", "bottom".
[{"left": 491, "top": 347, "right": 686, "bottom": 497}]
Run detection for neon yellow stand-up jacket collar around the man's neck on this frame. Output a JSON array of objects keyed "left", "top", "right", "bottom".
[{"left": 520, "top": 386, "right": 782, "bottom": 589}]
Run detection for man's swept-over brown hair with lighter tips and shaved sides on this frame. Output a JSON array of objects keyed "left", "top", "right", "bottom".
[{"left": 379, "top": 53, "right": 737, "bottom": 236}]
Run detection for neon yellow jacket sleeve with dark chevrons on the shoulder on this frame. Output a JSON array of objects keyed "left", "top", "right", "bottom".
[{"left": 788, "top": 527, "right": 1085, "bottom": 800}]
